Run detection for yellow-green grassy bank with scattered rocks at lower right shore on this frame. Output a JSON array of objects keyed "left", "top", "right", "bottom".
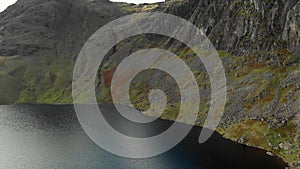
[{"left": 218, "top": 119, "right": 300, "bottom": 167}]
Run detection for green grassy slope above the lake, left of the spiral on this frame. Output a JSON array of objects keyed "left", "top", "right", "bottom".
[{"left": 0, "top": 56, "right": 73, "bottom": 103}]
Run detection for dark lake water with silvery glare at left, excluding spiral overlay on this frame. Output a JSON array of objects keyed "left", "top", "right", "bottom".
[{"left": 0, "top": 105, "right": 286, "bottom": 169}]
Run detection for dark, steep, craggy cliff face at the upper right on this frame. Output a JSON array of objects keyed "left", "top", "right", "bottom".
[{"left": 162, "top": 0, "right": 300, "bottom": 54}]
